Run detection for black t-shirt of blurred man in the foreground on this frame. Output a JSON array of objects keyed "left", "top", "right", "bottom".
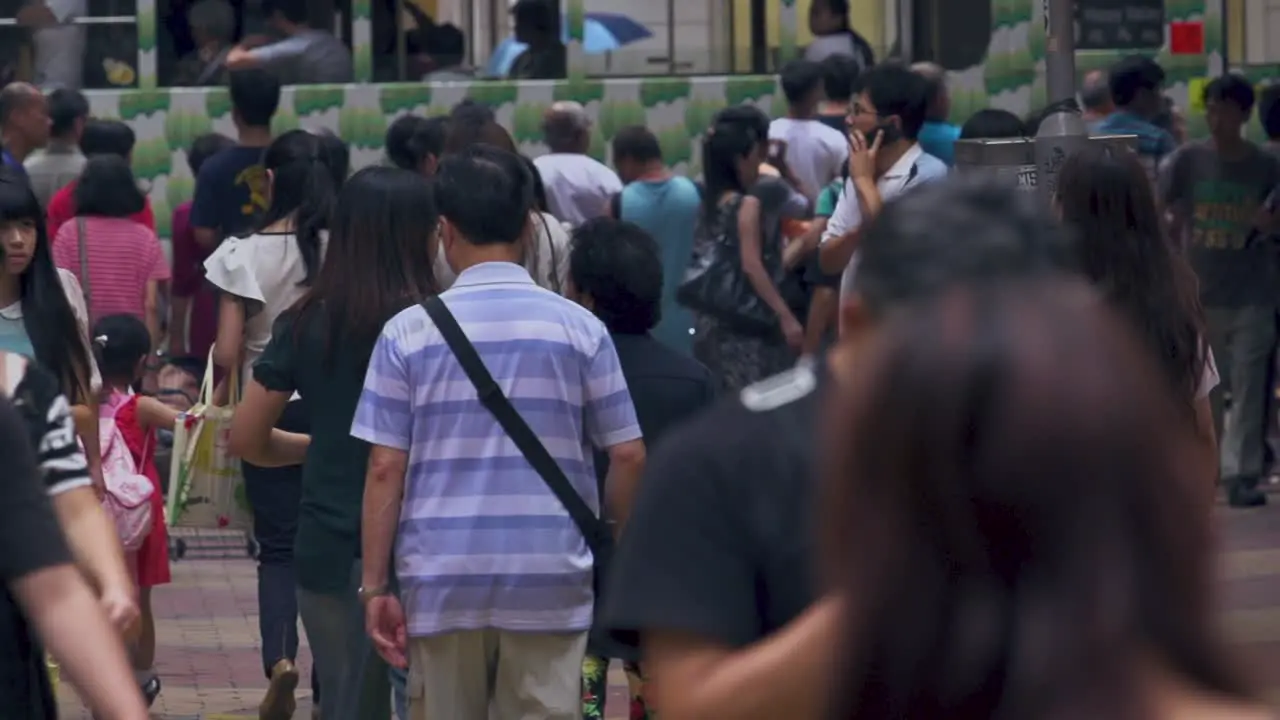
[{"left": 604, "top": 356, "right": 824, "bottom": 647}]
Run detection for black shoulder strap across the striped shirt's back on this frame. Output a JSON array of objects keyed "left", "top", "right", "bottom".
[{"left": 422, "top": 296, "right": 611, "bottom": 552}]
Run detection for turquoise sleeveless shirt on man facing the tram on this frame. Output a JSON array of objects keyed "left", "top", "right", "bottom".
[{"left": 621, "top": 177, "right": 701, "bottom": 354}]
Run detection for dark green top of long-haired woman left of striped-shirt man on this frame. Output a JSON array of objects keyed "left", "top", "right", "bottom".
[{"left": 253, "top": 304, "right": 372, "bottom": 593}]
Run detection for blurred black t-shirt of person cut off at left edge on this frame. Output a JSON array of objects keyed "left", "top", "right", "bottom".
[{"left": 0, "top": 396, "right": 72, "bottom": 720}]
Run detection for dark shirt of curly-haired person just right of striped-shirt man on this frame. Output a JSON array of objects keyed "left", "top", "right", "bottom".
[{"left": 595, "top": 333, "right": 716, "bottom": 497}]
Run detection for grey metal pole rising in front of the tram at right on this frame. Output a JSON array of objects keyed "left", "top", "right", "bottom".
[{"left": 1036, "top": 0, "right": 1089, "bottom": 201}]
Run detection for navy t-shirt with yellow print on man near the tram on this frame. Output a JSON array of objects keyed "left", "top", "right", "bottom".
[{"left": 191, "top": 145, "right": 268, "bottom": 237}]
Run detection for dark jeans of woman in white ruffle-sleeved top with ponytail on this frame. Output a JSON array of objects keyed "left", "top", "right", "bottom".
[{"left": 243, "top": 402, "right": 307, "bottom": 678}]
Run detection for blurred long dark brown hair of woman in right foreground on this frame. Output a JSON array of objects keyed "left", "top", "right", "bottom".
[{"left": 820, "top": 279, "right": 1249, "bottom": 720}]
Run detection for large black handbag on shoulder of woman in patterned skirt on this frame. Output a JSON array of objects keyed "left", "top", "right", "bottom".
[{"left": 676, "top": 195, "right": 782, "bottom": 337}]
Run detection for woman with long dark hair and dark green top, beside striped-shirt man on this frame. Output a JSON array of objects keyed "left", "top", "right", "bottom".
[{"left": 232, "top": 167, "right": 438, "bottom": 720}]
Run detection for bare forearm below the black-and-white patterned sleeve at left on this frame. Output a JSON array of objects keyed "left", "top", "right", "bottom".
[{"left": 54, "top": 487, "right": 133, "bottom": 594}]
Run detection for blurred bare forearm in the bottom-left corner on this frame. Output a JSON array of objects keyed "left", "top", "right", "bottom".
[{"left": 15, "top": 565, "right": 147, "bottom": 720}]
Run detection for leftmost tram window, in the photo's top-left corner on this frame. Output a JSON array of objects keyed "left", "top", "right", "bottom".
[{"left": 0, "top": 0, "right": 138, "bottom": 88}]
